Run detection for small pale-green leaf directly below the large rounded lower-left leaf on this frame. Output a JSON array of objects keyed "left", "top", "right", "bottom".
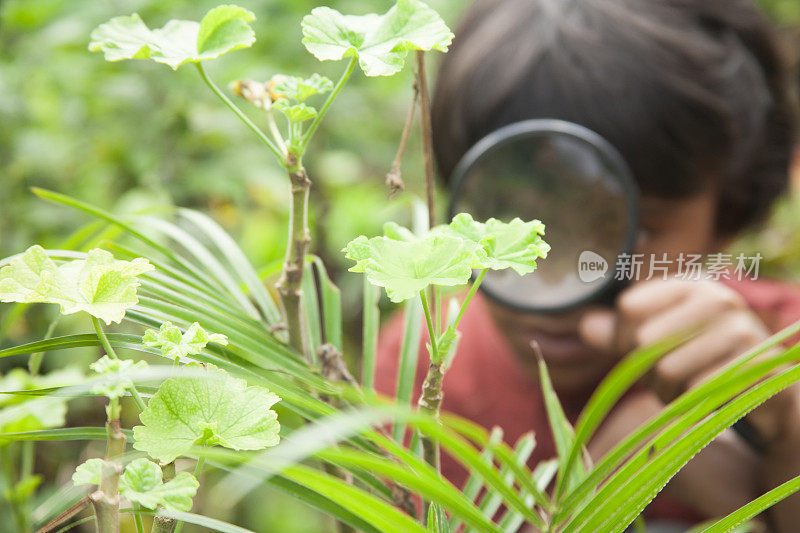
[{"left": 119, "top": 459, "right": 200, "bottom": 511}]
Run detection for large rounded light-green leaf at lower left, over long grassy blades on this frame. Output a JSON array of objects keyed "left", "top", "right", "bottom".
[{"left": 133, "top": 365, "right": 280, "bottom": 463}]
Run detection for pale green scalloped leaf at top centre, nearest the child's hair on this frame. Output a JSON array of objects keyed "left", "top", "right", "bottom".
[{"left": 302, "top": 0, "right": 453, "bottom": 76}]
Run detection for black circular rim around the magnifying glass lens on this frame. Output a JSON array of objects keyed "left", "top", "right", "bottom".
[{"left": 447, "top": 118, "right": 639, "bottom": 314}]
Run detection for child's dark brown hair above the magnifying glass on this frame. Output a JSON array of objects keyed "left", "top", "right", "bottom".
[{"left": 432, "top": 0, "right": 796, "bottom": 235}]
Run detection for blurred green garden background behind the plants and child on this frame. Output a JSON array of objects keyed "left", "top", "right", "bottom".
[{"left": 0, "top": 0, "right": 800, "bottom": 532}]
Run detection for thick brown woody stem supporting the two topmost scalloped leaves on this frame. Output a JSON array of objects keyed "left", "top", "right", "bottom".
[{"left": 276, "top": 152, "right": 311, "bottom": 361}]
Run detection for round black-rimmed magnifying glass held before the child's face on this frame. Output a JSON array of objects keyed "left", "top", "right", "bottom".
[{"left": 449, "top": 119, "right": 639, "bottom": 313}]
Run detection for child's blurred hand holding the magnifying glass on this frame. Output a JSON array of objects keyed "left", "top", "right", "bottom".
[{"left": 580, "top": 279, "right": 798, "bottom": 442}]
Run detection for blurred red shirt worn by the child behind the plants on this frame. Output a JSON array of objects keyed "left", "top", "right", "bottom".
[{"left": 375, "top": 280, "right": 800, "bottom": 523}]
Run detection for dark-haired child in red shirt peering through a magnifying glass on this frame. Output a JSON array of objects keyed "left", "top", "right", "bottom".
[{"left": 377, "top": 0, "right": 800, "bottom": 532}]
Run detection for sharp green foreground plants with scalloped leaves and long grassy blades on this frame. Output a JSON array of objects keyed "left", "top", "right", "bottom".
[{"left": 0, "top": 0, "right": 800, "bottom": 532}]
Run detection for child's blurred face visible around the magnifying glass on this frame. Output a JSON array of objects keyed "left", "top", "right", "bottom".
[{"left": 489, "top": 191, "right": 721, "bottom": 394}]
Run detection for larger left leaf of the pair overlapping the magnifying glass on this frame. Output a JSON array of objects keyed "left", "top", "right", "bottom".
[{"left": 344, "top": 235, "right": 474, "bottom": 302}]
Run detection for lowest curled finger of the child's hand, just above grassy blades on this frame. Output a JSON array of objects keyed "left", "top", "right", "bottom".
[{"left": 651, "top": 312, "right": 765, "bottom": 402}]
